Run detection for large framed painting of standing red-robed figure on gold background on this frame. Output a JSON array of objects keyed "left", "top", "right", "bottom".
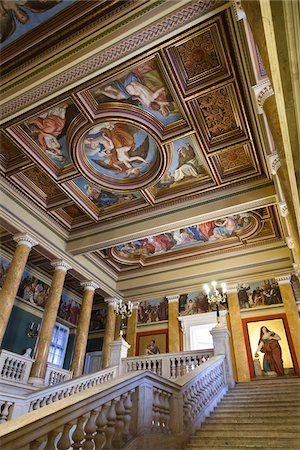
[{"left": 242, "top": 314, "right": 299, "bottom": 378}]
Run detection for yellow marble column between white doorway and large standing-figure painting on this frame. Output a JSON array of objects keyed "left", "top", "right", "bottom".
[{"left": 227, "top": 285, "right": 250, "bottom": 382}]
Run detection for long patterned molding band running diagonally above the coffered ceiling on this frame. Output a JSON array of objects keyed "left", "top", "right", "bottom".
[{"left": 0, "top": 0, "right": 220, "bottom": 119}]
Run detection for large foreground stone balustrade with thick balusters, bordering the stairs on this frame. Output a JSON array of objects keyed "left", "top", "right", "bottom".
[{"left": 0, "top": 356, "right": 228, "bottom": 450}]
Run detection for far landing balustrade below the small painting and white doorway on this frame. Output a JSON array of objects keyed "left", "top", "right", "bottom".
[{"left": 121, "top": 350, "right": 214, "bottom": 379}]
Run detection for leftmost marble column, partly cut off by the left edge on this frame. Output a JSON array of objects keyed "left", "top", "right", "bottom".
[{"left": 0, "top": 234, "right": 38, "bottom": 346}]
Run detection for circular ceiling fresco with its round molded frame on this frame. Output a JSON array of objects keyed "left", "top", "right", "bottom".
[{"left": 74, "top": 121, "right": 164, "bottom": 190}]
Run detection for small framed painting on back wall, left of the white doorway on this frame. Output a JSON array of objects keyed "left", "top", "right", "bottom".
[{"left": 136, "top": 330, "right": 169, "bottom": 356}]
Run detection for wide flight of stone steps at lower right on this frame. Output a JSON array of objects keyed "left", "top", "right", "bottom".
[{"left": 186, "top": 377, "right": 300, "bottom": 450}]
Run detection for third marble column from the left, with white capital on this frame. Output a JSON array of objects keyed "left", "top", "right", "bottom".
[{"left": 71, "top": 281, "right": 99, "bottom": 378}]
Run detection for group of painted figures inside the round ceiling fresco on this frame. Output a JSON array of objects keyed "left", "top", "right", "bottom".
[{"left": 85, "top": 123, "right": 151, "bottom": 176}]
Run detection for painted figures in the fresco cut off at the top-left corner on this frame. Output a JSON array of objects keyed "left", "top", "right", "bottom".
[{"left": 0, "top": 0, "right": 62, "bottom": 42}]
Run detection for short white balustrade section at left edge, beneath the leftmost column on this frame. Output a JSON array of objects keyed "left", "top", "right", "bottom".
[{"left": 0, "top": 350, "right": 34, "bottom": 384}]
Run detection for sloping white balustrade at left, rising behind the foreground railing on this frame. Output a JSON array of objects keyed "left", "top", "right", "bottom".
[{"left": 0, "top": 367, "right": 117, "bottom": 423}]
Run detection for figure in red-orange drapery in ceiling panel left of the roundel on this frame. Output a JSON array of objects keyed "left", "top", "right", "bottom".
[{"left": 27, "top": 103, "right": 68, "bottom": 162}]
